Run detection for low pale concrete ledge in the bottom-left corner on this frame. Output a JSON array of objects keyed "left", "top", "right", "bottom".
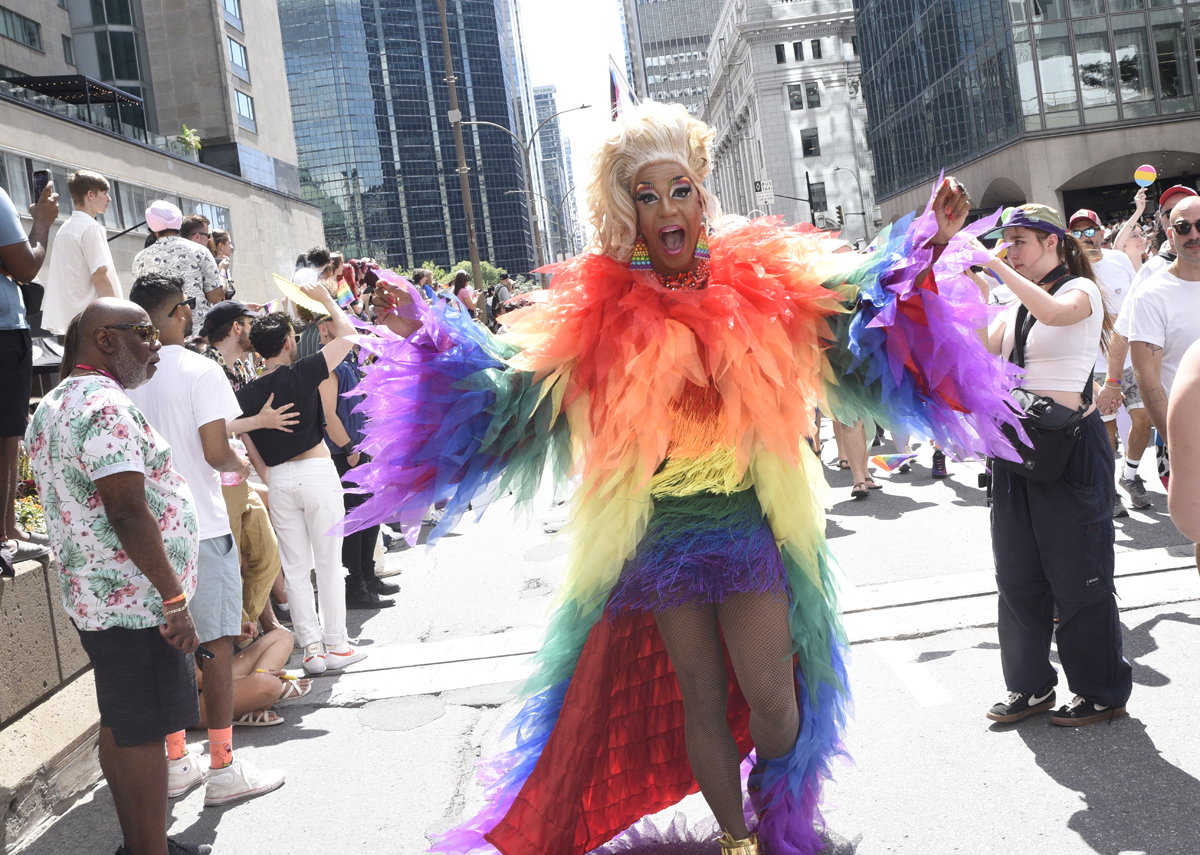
[{"left": 0, "top": 671, "right": 100, "bottom": 853}]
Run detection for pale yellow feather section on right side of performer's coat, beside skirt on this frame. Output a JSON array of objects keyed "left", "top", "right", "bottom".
[{"left": 750, "top": 443, "right": 834, "bottom": 598}]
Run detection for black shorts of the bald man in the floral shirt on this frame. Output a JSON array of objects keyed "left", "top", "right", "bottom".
[{"left": 79, "top": 627, "right": 200, "bottom": 748}]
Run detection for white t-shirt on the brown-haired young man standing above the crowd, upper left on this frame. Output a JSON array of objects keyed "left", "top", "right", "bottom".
[{"left": 42, "top": 211, "right": 125, "bottom": 334}]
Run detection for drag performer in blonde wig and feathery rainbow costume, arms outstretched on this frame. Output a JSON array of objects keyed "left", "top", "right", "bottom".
[{"left": 346, "top": 103, "right": 1016, "bottom": 855}]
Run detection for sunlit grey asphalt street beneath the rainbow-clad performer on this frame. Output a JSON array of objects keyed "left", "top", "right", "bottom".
[{"left": 18, "top": 434, "right": 1200, "bottom": 855}]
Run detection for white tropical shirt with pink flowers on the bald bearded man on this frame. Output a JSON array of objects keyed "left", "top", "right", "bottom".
[{"left": 25, "top": 375, "right": 199, "bottom": 632}]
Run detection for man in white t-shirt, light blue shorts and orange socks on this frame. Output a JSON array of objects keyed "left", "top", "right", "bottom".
[{"left": 130, "top": 274, "right": 283, "bottom": 806}]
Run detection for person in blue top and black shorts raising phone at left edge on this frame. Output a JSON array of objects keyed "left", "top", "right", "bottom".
[{"left": 0, "top": 174, "right": 59, "bottom": 574}]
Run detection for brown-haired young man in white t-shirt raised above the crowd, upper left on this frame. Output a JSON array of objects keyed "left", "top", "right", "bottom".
[{"left": 42, "top": 169, "right": 122, "bottom": 335}]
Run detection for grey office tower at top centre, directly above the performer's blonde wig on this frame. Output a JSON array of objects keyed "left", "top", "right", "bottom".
[{"left": 622, "top": 0, "right": 721, "bottom": 116}]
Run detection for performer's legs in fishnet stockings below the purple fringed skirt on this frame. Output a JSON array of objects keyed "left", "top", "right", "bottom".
[{"left": 654, "top": 593, "right": 800, "bottom": 838}]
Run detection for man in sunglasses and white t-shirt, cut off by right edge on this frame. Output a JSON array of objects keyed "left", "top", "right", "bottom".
[{"left": 1122, "top": 197, "right": 1200, "bottom": 511}]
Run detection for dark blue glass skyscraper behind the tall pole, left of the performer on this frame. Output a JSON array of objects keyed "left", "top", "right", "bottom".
[{"left": 278, "top": 0, "right": 541, "bottom": 273}]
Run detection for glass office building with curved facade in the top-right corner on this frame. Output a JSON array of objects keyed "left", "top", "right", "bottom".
[{"left": 854, "top": 0, "right": 1200, "bottom": 207}]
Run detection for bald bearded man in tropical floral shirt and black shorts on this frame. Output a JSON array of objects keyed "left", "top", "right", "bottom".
[{"left": 25, "top": 298, "right": 209, "bottom": 855}]
